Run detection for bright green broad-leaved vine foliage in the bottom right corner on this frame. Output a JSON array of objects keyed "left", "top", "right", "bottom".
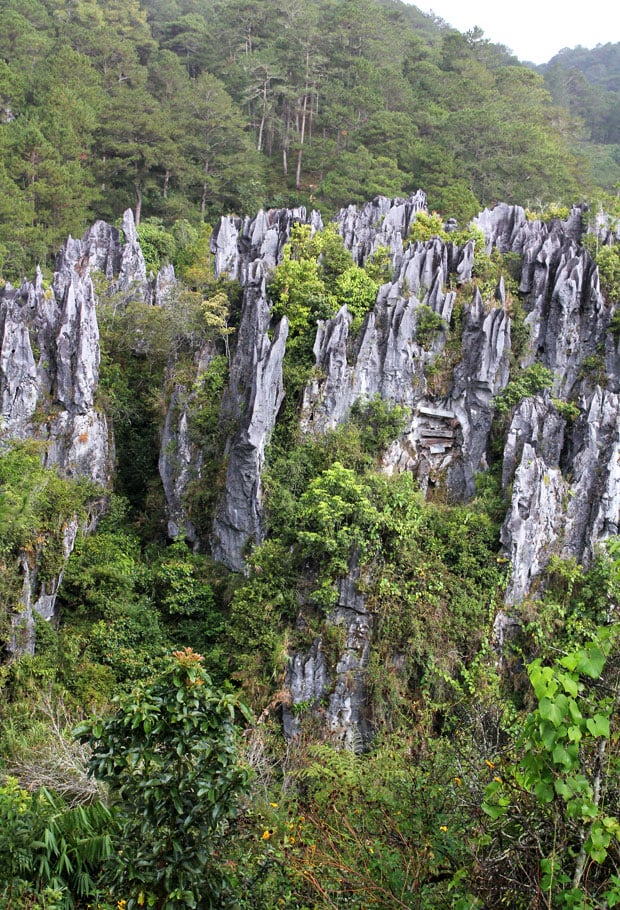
[{"left": 481, "top": 629, "right": 620, "bottom": 908}]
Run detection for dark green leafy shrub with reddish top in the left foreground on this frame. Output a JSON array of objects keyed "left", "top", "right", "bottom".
[{"left": 77, "top": 648, "right": 247, "bottom": 908}]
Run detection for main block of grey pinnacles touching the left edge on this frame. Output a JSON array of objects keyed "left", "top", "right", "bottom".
[{"left": 0, "top": 262, "right": 112, "bottom": 486}]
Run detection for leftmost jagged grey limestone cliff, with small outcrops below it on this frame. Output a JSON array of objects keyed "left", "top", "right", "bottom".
[{"left": 0, "top": 211, "right": 150, "bottom": 651}]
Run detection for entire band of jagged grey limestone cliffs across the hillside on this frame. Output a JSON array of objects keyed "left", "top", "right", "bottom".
[{"left": 0, "top": 191, "right": 620, "bottom": 745}]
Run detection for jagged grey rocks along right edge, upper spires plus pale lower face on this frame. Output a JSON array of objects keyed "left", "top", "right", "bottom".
[{"left": 477, "top": 206, "right": 620, "bottom": 605}]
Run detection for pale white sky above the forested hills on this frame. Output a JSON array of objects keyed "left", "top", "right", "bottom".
[{"left": 414, "top": 0, "right": 620, "bottom": 63}]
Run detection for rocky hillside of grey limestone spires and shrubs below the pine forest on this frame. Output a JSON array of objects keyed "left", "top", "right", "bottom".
[{"left": 0, "top": 190, "right": 620, "bottom": 910}]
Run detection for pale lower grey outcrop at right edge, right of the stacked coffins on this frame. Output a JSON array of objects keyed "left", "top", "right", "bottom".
[{"left": 502, "top": 387, "right": 620, "bottom": 604}]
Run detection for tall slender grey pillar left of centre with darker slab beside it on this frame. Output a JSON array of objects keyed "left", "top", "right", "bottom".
[{"left": 160, "top": 207, "right": 322, "bottom": 571}]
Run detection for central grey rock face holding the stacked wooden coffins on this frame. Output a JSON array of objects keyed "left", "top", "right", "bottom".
[{"left": 302, "top": 240, "right": 510, "bottom": 498}]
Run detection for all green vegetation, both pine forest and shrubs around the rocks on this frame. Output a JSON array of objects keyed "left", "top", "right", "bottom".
[{"left": 0, "top": 0, "right": 620, "bottom": 910}]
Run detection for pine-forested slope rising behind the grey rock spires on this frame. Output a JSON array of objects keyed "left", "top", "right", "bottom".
[{"left": 0, "top": 0, "right": 604, "bottom": 280}]
